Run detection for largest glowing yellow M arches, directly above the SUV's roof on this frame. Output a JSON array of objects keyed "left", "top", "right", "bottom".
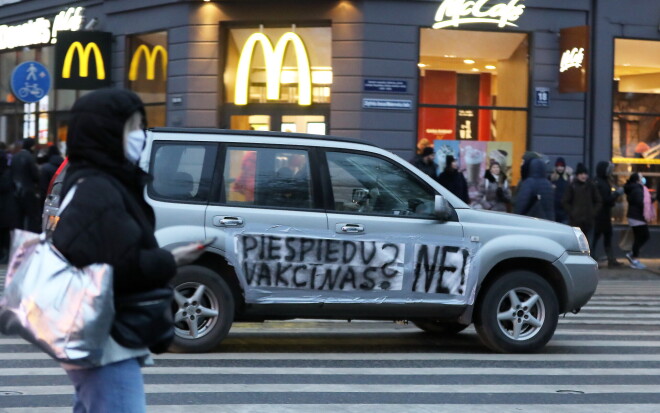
[{"left": 234, "top": 32, "right": 312, "bottom": 106}]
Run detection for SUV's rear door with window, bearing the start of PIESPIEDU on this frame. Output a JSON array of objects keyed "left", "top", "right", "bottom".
[{"left": 205, "top": 144, "right": 328, "bottom": 304}]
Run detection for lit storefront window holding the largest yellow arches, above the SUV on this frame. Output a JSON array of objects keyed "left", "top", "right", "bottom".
[{"left": 223, "top": 26, "right": 332, "bottom": 133}]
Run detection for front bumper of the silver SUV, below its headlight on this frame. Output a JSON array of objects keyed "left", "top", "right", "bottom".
[{"left": 553, "top": 251, "right": 598, "bottom": 312}]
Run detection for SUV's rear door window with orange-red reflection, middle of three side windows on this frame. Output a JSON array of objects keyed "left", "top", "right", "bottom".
[{"left": 223, "top": 147, "right": 313, "bottom": 209}]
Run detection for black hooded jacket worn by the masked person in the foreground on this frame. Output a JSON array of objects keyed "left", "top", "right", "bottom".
[{"left": 53, "top": 89, "right": 176, "bottom": 297}]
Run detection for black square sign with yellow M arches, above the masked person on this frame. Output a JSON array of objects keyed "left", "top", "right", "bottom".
[{"left": 55, "top": 31, "right": 112, "bottom": 90}]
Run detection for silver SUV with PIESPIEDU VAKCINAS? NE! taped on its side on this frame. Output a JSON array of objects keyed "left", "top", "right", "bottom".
[{"left": 43, "top": 128, "right": 598, "bottom": 352}]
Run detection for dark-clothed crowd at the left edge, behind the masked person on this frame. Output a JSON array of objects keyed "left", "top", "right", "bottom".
[{"left": 0, "top": 138, "right": 64, "bottom": 264}]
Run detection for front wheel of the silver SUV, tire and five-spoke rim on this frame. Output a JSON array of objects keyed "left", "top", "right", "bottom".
[{"left": 474, "top": 271, "right": 559, "bottom": 353}]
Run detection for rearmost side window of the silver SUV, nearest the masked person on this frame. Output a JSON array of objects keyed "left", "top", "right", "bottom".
[{"left": 148, "top": 142, "right": 217, "bottom": 202}]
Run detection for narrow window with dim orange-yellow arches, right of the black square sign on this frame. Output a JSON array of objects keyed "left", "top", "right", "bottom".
[{"left": 126, "top": 31, "right": 168, "bottom": 127}]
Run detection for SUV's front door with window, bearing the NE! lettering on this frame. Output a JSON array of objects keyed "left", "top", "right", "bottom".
[{"left": 325, "top": 149, "right": 476, "bottom": 304}]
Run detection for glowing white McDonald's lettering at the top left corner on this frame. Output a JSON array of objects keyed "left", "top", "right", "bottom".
[{"left": 0, "top": 7, "right": 85, "bottom": 50}]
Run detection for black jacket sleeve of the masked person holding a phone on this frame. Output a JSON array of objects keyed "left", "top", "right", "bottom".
[{"left": 53, "top": 178, "right": 176, "bottom": 292}]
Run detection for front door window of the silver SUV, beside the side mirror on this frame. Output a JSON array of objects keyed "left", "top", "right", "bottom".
[{"left": 327, "top": 152, "right": 435, "bottom": 218}]
